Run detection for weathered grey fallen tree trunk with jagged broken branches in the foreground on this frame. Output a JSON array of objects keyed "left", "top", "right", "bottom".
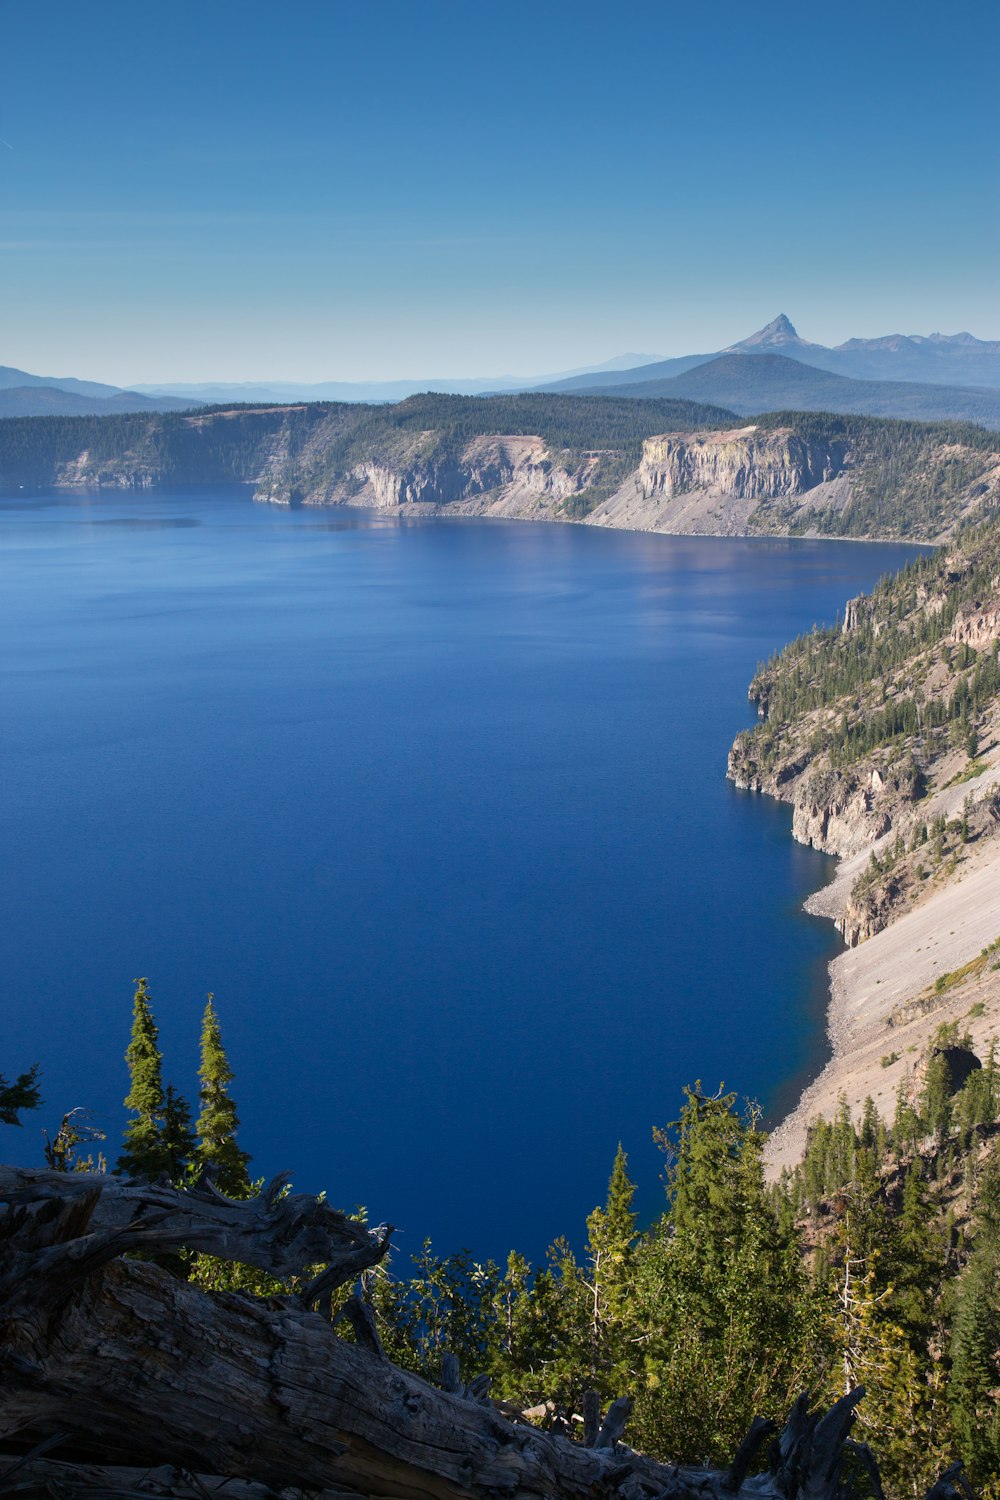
[{"left": 0, "top": 1170, "right": 971, "bottom": 1500}]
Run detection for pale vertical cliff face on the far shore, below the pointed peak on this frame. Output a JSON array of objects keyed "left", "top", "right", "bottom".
[{"left": 637, "top": 426, "right": 846, "bottom": 501}]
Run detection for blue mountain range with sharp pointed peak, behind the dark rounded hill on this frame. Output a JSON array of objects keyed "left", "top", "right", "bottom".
[{"left": 535, "top": 314, "right": 1000, "bottom": 396}]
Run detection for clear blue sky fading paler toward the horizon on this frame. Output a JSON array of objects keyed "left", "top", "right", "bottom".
[{"left": 0, "top": 0, "right": 1000, "bottom": 384}]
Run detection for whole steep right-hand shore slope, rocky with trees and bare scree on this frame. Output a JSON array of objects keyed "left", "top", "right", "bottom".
[{"left": 729, "top": 518, "right": 1000, "bottom": 1170}]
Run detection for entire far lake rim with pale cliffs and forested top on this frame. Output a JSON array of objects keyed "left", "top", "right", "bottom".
[{"left": 7, "top": 395, "right": 1000, "bottom": 546}]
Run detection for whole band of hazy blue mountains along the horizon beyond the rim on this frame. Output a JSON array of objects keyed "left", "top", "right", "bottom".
[{"left": 0, "top": 314, "right": 1000, "bottom": 428}]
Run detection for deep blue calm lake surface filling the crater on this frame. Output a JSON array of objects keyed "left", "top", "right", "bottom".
[{"left": 0, "top": 492, "right": 915, "bottom": 1257}]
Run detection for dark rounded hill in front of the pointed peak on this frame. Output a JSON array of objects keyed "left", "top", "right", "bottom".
[{"left": 563, "top": 353, "right": 1000, "bottom": 431}]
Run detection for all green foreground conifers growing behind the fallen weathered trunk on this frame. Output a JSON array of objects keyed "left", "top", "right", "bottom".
[{"left": 7, "top": 981, "right": 1000, "bottom": 1500}]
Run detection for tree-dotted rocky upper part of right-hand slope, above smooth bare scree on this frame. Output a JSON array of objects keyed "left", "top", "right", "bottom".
[{"left": 729, "top": 513, "right": 1000, "bottom": 941}]
